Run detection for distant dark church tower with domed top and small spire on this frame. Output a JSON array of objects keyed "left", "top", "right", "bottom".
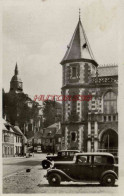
[{"left": 10, "top": 63, "right": 23, "bottom": 93}]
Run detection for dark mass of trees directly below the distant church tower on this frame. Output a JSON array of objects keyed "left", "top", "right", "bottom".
[{"left": 3, "top": 93, "right": 39, "bottom": 131}]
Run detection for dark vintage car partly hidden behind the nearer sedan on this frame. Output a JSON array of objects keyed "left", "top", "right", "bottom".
[{"left": 41, "top": 150, "right": 80, "bottom": 169}]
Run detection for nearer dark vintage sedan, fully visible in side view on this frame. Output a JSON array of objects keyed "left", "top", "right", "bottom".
[{"left": 45, "top": 153, "right": 118, "bottom": 186}]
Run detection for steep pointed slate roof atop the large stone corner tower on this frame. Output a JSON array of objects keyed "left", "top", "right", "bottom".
[{"left": 61, "top": 19, "right": 94, "bottom": 64}]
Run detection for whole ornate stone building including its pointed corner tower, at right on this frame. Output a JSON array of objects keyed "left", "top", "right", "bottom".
[{"left": 61, "top": 18, "right": 118, "bottom": 154}]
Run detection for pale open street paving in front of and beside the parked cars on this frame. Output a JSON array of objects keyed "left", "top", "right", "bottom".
[{"left": 3, "top": 154, "right": 118, "bottom": 193}]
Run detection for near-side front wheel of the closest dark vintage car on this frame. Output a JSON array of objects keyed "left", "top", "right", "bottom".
[{"left": 48, "top": 174, "right": 61, "bottom": 186}]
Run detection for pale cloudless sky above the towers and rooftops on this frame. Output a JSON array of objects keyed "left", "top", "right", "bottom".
[{"left": 2, "top": 0, "right": 119, "bottom": 97}]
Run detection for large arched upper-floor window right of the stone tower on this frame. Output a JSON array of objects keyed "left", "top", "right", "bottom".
[{"left": 103, "top": 92, "right": 117, "bottom": 114}]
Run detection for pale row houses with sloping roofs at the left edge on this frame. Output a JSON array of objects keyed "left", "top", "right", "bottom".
[{"left": 2, "top": 119, "right": 27, "bottom": 157}]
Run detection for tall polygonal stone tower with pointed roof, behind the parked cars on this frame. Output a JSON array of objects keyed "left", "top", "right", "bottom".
[{"left": 61, "top": 16, "right": 98, "bottom": 151}]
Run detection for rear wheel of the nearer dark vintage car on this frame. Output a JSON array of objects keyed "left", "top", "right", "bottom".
[{"left": 101, "top": 174, "right": 115, "bottom": 186}]
